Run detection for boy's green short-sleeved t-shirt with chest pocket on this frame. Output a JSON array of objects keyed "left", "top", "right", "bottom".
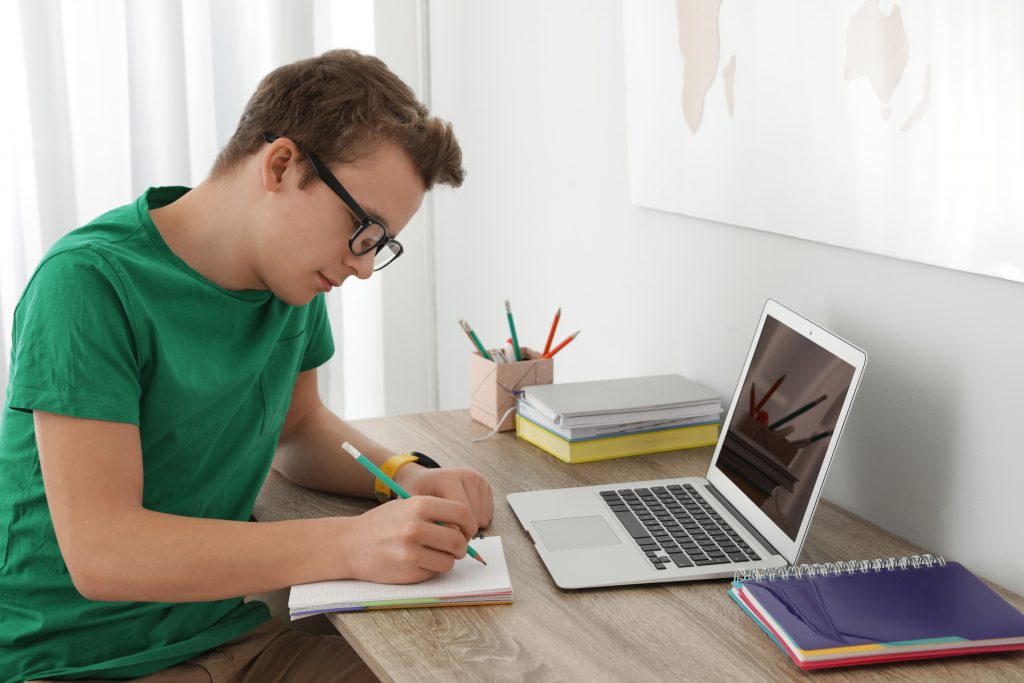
[{"left": 0, "top": 187, "right": 334, "bottom": 682}]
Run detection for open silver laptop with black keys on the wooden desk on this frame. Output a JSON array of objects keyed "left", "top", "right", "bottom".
[{"left": 508, "top": 299, "right": 866, "bottom": 589}]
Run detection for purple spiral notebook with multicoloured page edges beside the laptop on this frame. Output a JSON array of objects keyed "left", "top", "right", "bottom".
[{"left": 729, "top": 555, "right": 1024, "bottom": 669}]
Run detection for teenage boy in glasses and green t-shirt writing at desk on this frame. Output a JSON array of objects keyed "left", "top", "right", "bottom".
[{"left": 0, "top": 50, "right": 493, "bottom": 681}]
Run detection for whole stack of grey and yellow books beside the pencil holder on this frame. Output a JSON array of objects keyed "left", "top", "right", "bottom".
[{"left": 516, "top": 375, "right": 722, "bottom": 463}]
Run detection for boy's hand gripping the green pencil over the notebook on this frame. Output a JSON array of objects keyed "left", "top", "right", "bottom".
[{"left": 343, "top": 496, "right": 477, "bottom": 584}]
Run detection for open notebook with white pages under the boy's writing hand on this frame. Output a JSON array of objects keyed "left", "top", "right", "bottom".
[{"left": 288, "top": 536, "right": 512, "bottom": 620}]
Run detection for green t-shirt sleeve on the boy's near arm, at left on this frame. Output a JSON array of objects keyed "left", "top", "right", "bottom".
[{"left": 8, "top": 248, "right": 141, "bottom": 425}]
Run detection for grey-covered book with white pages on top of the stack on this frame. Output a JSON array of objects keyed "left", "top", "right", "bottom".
[{"left": 523, "top": 375, "right": 722, "bottom": 427}]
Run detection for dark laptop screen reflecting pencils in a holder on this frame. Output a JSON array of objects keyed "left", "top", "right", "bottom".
[{"left": 716, "top": 315, "right": 854, "bottom": 540}]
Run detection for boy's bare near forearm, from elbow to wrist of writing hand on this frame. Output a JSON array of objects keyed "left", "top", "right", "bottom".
[{"left": 73, "top": 508, "right": 351, "bottom": 602}]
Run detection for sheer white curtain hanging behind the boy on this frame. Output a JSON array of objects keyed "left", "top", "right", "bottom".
[{"left": 0, "top": 0, "right": 399, "bottom": 417}]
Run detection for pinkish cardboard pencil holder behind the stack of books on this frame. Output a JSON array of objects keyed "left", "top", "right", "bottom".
[{"left": 469, "top": 346, "right": 555, "bottom": 431}]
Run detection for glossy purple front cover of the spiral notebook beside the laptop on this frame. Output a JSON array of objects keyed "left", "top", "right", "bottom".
[{"left": 742, "top": 562, "right": 1024, "bottom": 650}]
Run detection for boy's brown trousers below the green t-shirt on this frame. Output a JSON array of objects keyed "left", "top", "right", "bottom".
[{"left": 37, "top": 617, "right": 379, "bottom": 683}]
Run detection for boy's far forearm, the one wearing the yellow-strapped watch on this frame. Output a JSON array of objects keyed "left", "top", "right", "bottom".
[{"left": 273, "top": 405, "right": 394, "bottom": 498}]
